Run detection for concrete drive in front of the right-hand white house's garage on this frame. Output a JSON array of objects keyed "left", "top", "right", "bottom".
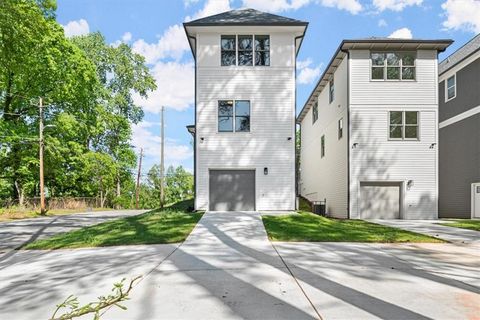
[{"left": 372, "top": 220, "right": 480, "bottom": 245}]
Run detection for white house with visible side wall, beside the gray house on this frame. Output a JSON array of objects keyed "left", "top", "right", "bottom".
[{"left": 297, "top": 38, "right": 452, "bottom": 219}]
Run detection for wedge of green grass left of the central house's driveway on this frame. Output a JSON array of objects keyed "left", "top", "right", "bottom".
[{"left": 23, "top": 201, "right": 202, "bottom": 249}]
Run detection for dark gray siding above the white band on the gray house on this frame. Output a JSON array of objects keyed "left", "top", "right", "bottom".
[{"left": 438, "top": 59, "right": 480, "bottom": 122}]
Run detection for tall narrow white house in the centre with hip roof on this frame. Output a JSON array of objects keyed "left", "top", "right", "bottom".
[{"left": 184, "top": 9, "right": 307, "bottom": 211}]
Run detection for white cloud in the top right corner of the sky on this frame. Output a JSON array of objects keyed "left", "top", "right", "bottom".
[{"left": 442, "top": 0, "right": 480, "bottom": 33}]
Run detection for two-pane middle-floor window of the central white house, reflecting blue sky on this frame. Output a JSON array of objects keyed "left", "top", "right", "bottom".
[{"left": 218, "top": 100, "right": 250, "bottom": 132}]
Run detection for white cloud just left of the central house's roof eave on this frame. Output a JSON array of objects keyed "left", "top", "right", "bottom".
[{"left": 132, "top": 24, "right": 190, "bottom": 64}]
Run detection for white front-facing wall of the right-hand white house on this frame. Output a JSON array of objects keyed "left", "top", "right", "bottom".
[{"left": 349, "top": 50, "right": 438, "bottom": 219}]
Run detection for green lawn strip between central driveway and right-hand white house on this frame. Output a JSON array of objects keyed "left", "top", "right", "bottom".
[{"left": 262, "top": 211, "right": 445, "bottom": 243}]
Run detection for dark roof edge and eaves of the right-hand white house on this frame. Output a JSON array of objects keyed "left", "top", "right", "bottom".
[{"left": 297, "top": 37, "right": 453, "bottom": 123}]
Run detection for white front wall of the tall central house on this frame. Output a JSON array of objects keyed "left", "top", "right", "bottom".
[{"left": 195, "top": 27, "right": 295, "bottom": 210}]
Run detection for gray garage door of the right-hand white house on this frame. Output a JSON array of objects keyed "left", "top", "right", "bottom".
[{"left": 360, "top": 182, "right": 401, "bottom": 219}]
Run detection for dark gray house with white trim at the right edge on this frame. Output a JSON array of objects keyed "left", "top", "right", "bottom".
[{"left": 438, "top": 34, "right": 480, "bottom": 218}]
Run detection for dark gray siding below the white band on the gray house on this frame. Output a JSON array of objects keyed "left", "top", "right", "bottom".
[{"left": 439, "top": 113, "right": 480, "bottom": 218}]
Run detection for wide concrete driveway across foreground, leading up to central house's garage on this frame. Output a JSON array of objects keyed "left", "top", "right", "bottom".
[{"left": 0, "top": 213, "right": 480, "bottom": 320}]
